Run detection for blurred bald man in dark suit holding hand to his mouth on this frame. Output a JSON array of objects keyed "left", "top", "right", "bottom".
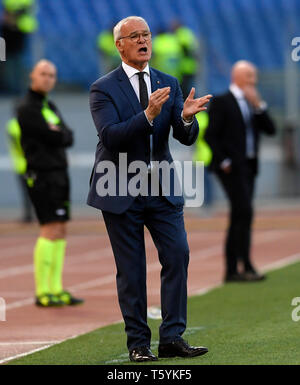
[{"left": 205, "top": 60, "right": 275, "bottom": 282}]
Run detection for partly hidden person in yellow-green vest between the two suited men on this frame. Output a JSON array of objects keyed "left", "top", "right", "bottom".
[{"left": 193, "top": 111, "right": 213, "bottom": 208}]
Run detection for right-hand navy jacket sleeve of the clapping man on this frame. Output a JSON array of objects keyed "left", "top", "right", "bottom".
[{"left": 171, "top": 80, "right": 199, "bottom": 146}]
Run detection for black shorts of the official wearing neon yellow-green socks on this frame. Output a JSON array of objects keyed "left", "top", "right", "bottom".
[{"left": 25, "top": 170, "right": 70, "bottom": 225}]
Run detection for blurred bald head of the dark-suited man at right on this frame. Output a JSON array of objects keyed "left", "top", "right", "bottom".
[{"left": 231, "top": 60, "right": 257, "bottom": 90}]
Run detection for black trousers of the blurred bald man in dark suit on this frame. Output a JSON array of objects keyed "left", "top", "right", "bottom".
[{"left": 217, "top": 160, "right": 255, "bottom": 274}]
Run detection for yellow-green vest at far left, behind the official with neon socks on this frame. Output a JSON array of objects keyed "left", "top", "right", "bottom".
[{"left": 6, "top": 119, "right": 27, "bottom": 175}]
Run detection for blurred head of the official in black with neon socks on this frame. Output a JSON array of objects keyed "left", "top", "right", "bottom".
[{"left": 30, "top": 59, "right": 57, "bottom": 94}]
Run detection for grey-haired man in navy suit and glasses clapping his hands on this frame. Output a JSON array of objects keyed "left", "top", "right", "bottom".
[{"left": 88, "top": 16, "right": 211, "bottom": 362}]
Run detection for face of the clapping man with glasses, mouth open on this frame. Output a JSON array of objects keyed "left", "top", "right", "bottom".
[{"left": 116, "top": 20, "right": 152, "bottom": 70}]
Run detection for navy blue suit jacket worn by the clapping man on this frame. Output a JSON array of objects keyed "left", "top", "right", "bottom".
[{"left": 87, "top": 65, "right": 199, "bottom": 214}]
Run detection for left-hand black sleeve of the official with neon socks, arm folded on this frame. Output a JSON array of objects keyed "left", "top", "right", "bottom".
[{"left": 17, "top": 106, "right": 73, "bottom": 147}]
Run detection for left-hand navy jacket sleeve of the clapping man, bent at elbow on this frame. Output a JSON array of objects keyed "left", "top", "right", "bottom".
[{"left": 90, "top": 84, "right": 152, "bottom": 151}]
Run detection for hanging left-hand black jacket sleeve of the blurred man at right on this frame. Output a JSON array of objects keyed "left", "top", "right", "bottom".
[{"left": 204, "top": 98, "right": 226, "bottom": 164}]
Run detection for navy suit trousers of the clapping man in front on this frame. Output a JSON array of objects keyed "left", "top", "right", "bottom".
[{"left": 102, "top": 182, "right": 189, "bottom": 350}]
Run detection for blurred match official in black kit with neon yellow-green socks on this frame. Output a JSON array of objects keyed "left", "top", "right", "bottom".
[{"left": 17, "top": 60, "right": 83, "bottom": 307}]
